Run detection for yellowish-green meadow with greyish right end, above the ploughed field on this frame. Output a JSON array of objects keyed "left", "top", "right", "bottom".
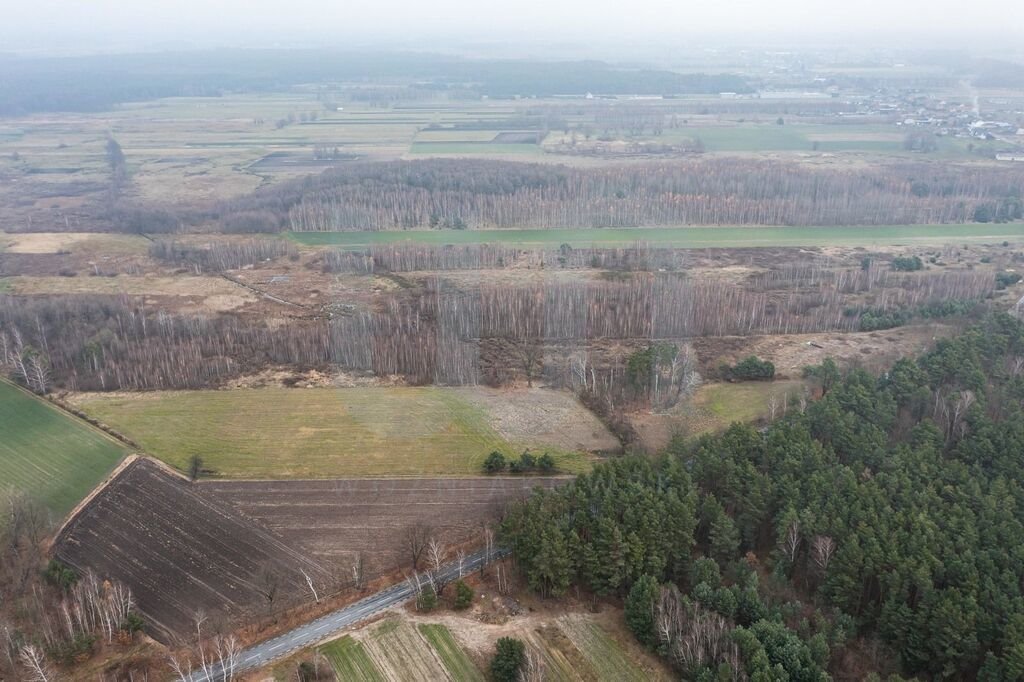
[{"left": 73, "top": 387, "right": 617, "bottom": 478}]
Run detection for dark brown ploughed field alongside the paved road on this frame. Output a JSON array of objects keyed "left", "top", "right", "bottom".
[{"left": 54, "top": 458, "right": 567, "bottom": 641}]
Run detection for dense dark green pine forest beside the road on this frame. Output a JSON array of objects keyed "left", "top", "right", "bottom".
[{"left": 503, "top": 314, "right": 1024, "bottom": 681}]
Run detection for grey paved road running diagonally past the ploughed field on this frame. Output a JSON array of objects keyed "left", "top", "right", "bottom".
[{"left": 188, "top": 549, "right": 508, "bottom": 682}]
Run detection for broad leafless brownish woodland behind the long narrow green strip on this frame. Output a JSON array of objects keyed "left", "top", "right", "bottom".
[{"left": 219, "top": 159, "right": 1024, "bottom": 231}]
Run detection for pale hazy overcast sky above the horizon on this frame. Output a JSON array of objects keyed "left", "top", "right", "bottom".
[{"left": 0, "top": 0, "right": 1024, "bottom": 51}]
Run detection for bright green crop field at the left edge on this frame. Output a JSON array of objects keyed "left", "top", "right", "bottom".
[{"left": 0, "top": 381, "right": 125, "bottom": 516}]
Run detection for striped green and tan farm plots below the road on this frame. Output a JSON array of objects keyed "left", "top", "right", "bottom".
[{"left": 319, "top": 613, "right": 664, "bottom": 682}]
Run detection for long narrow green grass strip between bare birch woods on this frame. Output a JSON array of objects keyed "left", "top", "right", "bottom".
[{"left": 289, "top": 222, "right": 1024, "bottom": 249}]
